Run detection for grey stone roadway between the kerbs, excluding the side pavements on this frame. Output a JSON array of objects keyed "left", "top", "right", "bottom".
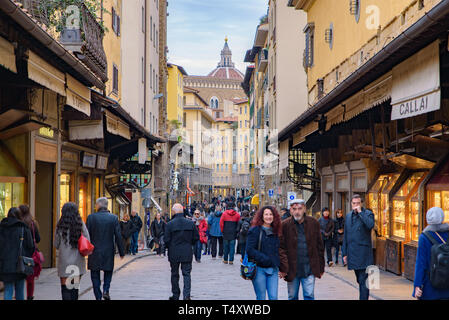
[{"left": 80, "top": 255, "right": 358, "bottom": 300}]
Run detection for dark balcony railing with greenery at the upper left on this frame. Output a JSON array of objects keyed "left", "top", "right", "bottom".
[{"left": 17, "top": 0, "right": 108, "bottom": 82}]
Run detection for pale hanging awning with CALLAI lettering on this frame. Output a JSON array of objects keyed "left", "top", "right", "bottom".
[{"left": 391, "top": 41, "right": 441, "bottom": 120}]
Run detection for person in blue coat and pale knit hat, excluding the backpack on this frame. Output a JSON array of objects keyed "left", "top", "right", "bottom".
[{"left": 413, "top": 207, "right": 449, "bottom": 300}]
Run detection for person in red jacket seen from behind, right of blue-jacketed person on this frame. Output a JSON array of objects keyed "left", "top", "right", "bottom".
[{"left": 220, "top": 201, "right": 240, "bottom": 264}]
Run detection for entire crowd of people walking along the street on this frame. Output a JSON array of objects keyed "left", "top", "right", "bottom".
[{"left": 0, "top": 195, "right": 449, "bottom": 300}]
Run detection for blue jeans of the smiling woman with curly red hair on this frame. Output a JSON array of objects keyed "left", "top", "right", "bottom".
[{"left": 252, "top": 267, "right": 279, "bottom": 300}]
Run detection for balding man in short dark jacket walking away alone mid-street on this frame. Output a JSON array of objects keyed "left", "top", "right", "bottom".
[{"left": 164, "top": 203, "right": 200, "bottom": 300}]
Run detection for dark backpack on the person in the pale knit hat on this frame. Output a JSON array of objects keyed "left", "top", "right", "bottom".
[{"left": 423, "top": 232, "right": 449, "bottom": 289}]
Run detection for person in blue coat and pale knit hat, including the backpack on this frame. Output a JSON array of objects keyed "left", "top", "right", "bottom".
[{"left": 412, "top": 207, "right": 449, "bottom": 300}]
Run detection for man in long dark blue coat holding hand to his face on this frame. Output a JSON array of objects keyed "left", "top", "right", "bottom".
[{"left": 342, "top": 194, "right": 374, "bottom": 300}]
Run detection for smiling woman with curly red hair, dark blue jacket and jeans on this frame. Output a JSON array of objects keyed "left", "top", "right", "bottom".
[{"left": 246, "top": 206, "right": 281, "bottom": 300}]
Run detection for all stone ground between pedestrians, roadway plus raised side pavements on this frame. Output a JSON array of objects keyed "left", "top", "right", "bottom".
[{"left": 5, "top": 251, "right": 413, "bottom": 300}]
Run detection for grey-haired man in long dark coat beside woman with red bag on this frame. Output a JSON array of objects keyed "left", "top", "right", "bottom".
[{"left": 86, "top": 198, "right": 125, "bottom": 300}]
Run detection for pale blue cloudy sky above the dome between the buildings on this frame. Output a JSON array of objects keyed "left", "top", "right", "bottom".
[{"left": 167, "top": 0, "right": 268, "bottom": 75}]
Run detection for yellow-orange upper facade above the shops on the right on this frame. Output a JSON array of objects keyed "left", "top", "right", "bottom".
[{"left": 289, "top": 0, "right": 441, "bottom": 105}]
